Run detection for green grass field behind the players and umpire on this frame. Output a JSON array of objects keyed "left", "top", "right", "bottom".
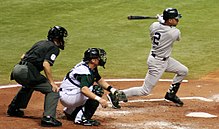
[{"left": 0, "top": 0, "right": 219, "bottom": 84}]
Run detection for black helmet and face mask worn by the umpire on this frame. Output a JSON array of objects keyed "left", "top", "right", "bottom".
[{"left": 47, "top": 26, "right": 68, "bottom": 50}]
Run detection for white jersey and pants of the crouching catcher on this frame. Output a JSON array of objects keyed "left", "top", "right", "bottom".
[{"left": 59, "top": 61, "right": 100, "bottom": 119}]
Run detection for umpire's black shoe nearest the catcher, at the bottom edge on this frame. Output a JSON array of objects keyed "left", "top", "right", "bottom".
[{"left": 41, "top": 116, "right": 62, "bottom": 127}]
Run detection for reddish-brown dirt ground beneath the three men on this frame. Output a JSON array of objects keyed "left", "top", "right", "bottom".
[{"left": 0, "top": 71, "right": 219, "bottom": 129}]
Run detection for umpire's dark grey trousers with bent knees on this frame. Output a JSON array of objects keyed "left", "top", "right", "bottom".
[{"left": 9, "top": 63, "right": 59, "bottom": 118}]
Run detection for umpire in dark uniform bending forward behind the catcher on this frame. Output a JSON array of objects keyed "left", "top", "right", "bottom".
[{"left": 7, "top": 26, "right": 67, "bottom": 127}]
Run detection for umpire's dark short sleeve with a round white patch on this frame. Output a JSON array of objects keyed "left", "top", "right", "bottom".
[{"left": 45, "top": 46, "right": 60, "bottom": 66}]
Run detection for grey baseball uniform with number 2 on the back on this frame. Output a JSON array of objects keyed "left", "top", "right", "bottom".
[{"left": 123, "top": 22, "right": 188, "bottom": 97}]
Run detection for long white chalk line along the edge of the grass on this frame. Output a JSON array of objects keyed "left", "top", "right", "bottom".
[{"left": 0, "top": 78, "right": 188, "bottom": 89}]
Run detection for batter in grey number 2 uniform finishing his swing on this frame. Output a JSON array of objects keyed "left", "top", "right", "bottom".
[{"left": 108, "top": 8, "right": 188, "bottom": 106}]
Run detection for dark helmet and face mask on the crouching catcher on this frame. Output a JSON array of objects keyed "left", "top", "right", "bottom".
[{"left": 83, "top": 48, "right": 107, "bottom": 68}]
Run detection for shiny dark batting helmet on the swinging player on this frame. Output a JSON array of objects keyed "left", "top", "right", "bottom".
[{"left": 163, "top": 8, "right": 182, "bottom": 20}]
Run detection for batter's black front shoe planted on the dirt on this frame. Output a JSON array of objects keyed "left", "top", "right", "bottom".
[{"left": 165, "top": 92, "right": 183, "bottom": 107}]
